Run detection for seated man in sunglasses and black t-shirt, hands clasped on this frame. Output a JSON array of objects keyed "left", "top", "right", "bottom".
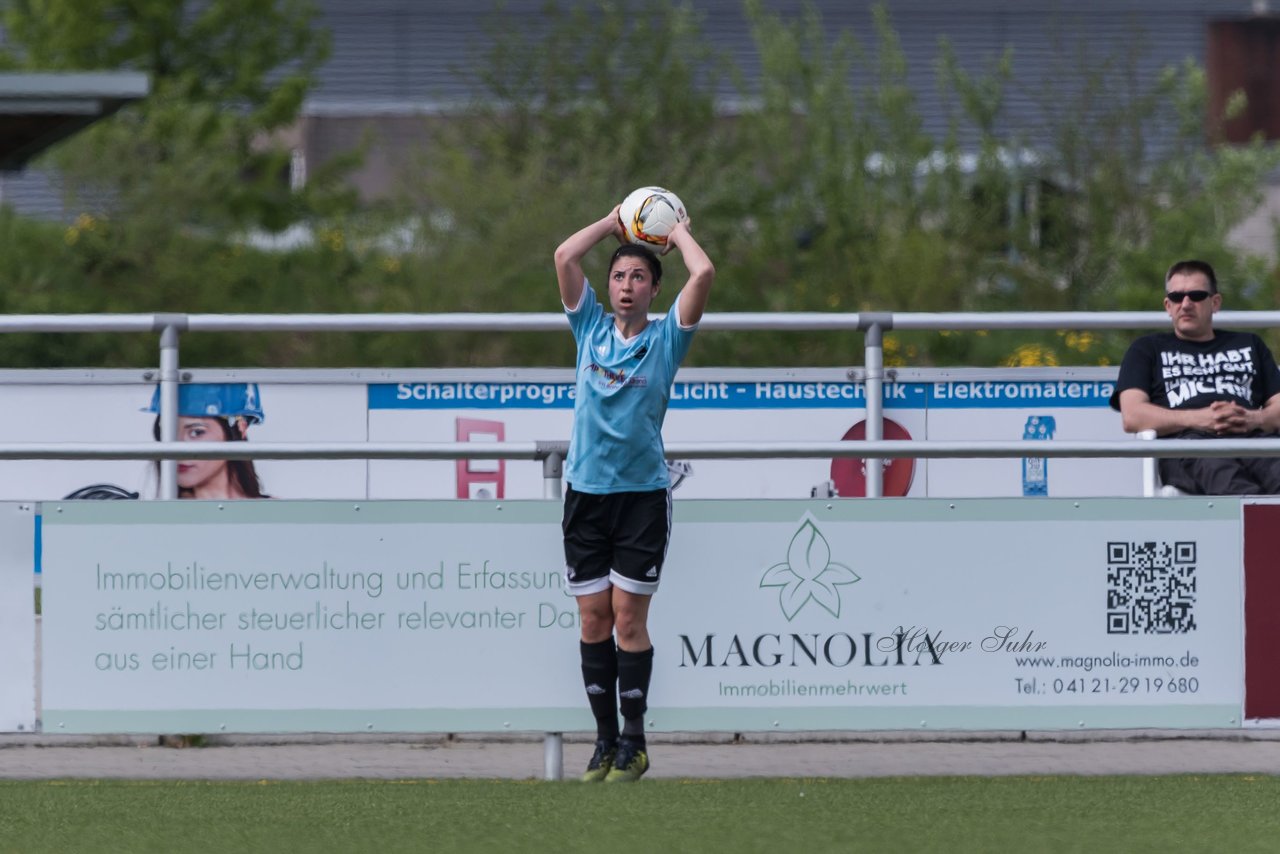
[{"left": 1111, "top": 261, "right": 1280, "bottom": 495}]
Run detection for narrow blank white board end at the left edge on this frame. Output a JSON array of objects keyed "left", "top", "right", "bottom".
[{"left": 0, "top": 502, "right": 36, "bottom": 732}]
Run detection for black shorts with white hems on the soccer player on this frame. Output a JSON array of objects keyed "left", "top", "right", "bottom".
[{"left": 561, "top": 487, "right": 671, "bottom": 595}]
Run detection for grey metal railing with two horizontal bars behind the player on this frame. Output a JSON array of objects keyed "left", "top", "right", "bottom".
[{"left": 0, "top": 311, "right": 1280, "bottom": 498}]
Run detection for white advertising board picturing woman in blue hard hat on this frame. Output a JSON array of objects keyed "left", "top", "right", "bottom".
[{"left": 0, "top": 370, "right": 369, "bottom": 501}]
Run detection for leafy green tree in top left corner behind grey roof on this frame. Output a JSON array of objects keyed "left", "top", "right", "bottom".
[{"left": 4, "top": 0, "right": 345, "bottom": 234}]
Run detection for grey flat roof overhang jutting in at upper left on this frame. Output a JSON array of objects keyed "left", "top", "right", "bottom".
[{"left": 0, "top": 72, "right": 150, "bottom": 172}]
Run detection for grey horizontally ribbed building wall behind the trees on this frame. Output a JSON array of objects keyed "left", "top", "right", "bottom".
[{"left": 305, "top": 0, "right": 1249, "bottom": 125}]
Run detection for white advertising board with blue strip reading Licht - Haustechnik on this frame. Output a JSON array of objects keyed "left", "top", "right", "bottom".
[{"left": 369, "top": 369, "right": 1142, "bottom": 498}]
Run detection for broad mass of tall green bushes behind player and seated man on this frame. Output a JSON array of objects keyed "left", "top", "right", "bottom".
[{"left": 413, "top": 0, "right": 1280, "bottom": 365}]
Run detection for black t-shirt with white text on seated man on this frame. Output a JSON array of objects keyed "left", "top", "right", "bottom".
[{"left": 1111, "top": 329, "right": 1280, "bottom": 410}]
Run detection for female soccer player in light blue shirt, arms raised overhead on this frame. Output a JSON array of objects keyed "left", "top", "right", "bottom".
[{"left": 556, "top": 207, "right": 716, "bottom": 782}]
